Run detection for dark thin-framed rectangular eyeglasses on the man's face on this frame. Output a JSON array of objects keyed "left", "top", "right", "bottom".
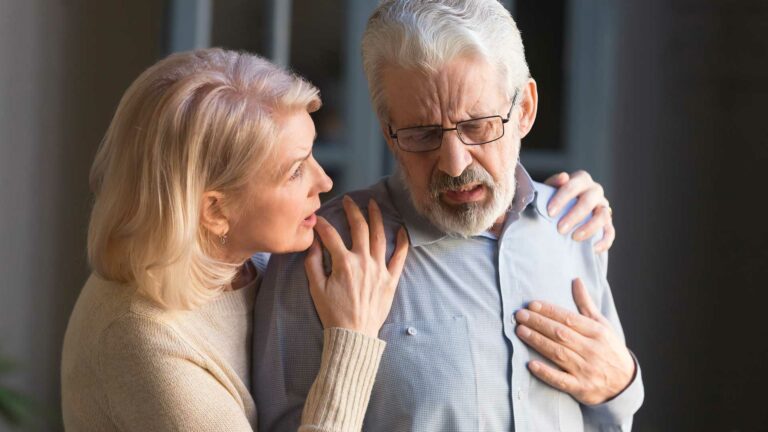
[{"left": 387, "top": 91, "right": 517, "bottom": 153}]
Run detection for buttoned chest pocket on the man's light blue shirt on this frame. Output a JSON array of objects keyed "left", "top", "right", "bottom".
[{"left": 363, "top": 317, "right": 478, "bottom": 432}]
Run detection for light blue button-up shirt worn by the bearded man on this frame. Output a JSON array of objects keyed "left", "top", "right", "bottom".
[{"left": 253, "top": 165, "right": 643, "bottom": 432}]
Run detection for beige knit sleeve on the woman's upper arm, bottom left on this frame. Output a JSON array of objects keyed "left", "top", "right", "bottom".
[{"left": 98, "top": 315, "right": 252, "bottom": 432}]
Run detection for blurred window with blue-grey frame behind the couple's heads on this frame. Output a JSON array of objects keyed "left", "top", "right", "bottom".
[{"left": 167, "top": 0, "right": 616, "bottom": 190}]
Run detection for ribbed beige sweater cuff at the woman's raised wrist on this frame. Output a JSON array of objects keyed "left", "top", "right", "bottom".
[{"left": 299, "top": 327, "right": 386, "bottom": 432}]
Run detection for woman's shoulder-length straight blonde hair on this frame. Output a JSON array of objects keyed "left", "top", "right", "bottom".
[{"left": 88, "top": 48, "right": 320, "bottom": 309}]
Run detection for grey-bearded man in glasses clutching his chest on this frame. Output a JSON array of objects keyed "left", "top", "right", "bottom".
[{"left": 253, "top": 0, "right": 643, "bottom": 432}]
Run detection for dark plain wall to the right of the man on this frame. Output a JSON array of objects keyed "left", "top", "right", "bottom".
[{"left": 610, "top": 0, "right": 768, "bottom": 431}]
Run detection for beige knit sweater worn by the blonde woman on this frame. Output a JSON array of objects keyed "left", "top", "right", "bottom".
[{"left": 61, "top": 276, "right": 385, "bottom": 432}]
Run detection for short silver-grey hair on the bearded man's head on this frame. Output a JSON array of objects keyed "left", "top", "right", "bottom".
[{"left": 362, "top": 0, "right": 530, "bottom": 121}]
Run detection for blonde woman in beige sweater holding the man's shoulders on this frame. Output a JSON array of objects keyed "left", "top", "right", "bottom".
[{"left": 62, "top": 49, "right": 612, "bottom": 431}]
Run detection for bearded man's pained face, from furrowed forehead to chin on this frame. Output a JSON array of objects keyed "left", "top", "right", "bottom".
[{"left": 382, "top": 57, "right": 520, "bottom": 236}]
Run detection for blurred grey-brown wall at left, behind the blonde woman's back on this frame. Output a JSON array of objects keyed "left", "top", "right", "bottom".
[{"left": 0, "top": 0, "right": 162, "bottom": 430}]
